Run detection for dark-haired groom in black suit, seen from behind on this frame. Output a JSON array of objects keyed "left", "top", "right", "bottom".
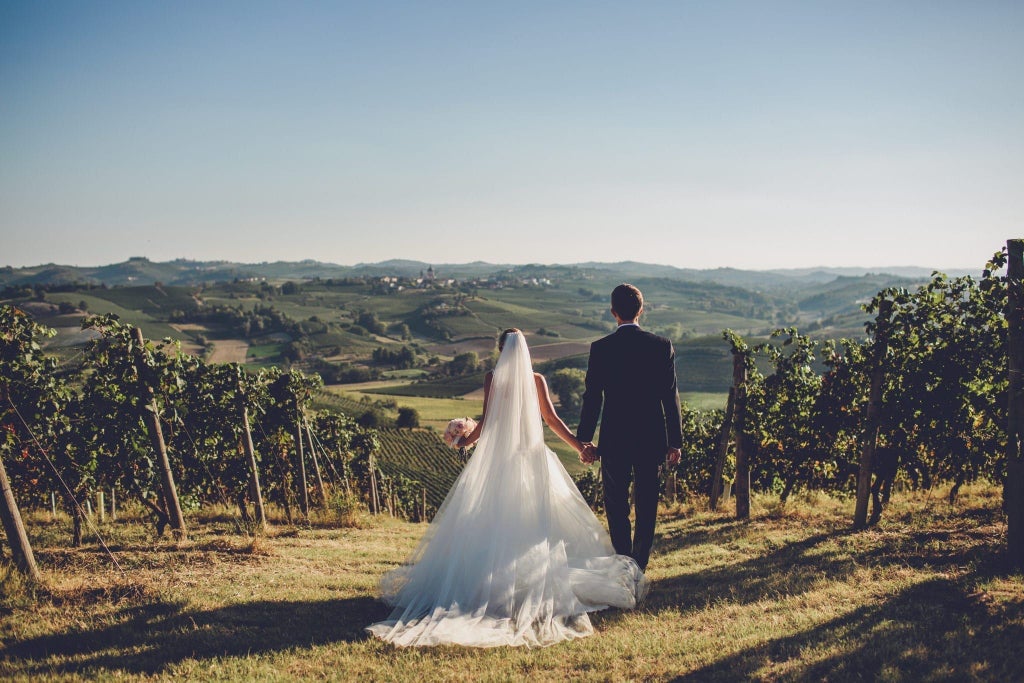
[{"left": 577, "top": 285, "right": 682, "bottom": 570}]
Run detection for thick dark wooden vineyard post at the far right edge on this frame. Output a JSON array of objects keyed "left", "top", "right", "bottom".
[{"left": 1002, "top": 240, "right": 1024, "bottom": 570}]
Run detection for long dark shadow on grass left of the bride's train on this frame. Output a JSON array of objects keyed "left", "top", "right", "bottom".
[{"left": 0, "top": 597, "right": 390, "bottom": 676}]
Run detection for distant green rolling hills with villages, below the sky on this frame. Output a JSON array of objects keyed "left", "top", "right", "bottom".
[{"left": 0, "top": 257, "right": 958, "bottom": 395}]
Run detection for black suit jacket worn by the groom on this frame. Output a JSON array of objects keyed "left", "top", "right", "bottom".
[{"left": 577, "top": 325, "right": 683, "bottom": 458}]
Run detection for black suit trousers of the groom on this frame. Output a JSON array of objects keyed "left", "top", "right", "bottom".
[{"left": 601, "top": 453, "right": 660, "bottom": 570}]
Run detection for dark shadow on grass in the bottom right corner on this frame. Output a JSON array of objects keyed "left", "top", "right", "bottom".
[{"left": 676, "top": 579, "right": 1024, "bottom": 681}]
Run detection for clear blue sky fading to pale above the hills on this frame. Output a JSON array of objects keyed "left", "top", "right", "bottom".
[{"left": 0, "top": 0, "right": 1024, "bottom": 268}]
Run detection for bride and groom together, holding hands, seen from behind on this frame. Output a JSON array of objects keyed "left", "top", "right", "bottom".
[{"left": 368, "top": 285, "right": 682, "bottom": 647}]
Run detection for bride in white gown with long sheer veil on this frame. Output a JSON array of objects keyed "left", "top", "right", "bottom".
[{"left": 367, "top": 329, "right": 647, "bottom": 647}]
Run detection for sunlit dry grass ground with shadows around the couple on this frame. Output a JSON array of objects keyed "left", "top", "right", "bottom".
[{"left": 0, "top": 487, "right": 1024, "bottom": 682}]
